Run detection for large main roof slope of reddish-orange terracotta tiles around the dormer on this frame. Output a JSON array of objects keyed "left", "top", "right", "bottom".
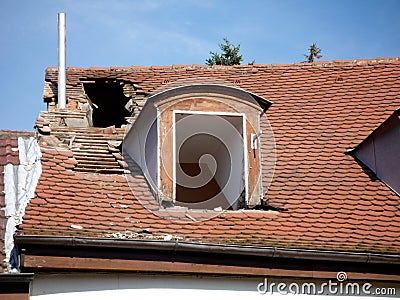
[{"left": 21, "top": 58, "right": 400, "bottom": 254}]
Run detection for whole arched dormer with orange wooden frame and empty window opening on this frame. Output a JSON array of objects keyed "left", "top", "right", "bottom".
[{"left": 123, "top": 84, "right": 271, "bottom": 210}]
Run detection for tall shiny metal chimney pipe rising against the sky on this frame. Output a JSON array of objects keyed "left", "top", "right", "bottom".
[{"left": 58, "top": 13, "right": 67, "bottom": 109}]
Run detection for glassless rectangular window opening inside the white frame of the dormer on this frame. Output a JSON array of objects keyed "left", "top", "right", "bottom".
[{"left": 175, "top": 113, "right": 245, "bottom": 209}]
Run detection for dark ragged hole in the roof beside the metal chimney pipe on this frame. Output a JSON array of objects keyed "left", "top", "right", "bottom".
[{"left": 83, "top": 79, "right": 130, "bottom": 127}]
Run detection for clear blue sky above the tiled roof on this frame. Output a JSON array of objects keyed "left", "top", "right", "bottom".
[{"left": 0, "top": 0, "right": 400, "bottom": 130}]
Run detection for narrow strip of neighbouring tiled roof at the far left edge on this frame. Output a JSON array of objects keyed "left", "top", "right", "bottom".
[{"left": 0, "top": 130, "right": 33, "bottom": 273}]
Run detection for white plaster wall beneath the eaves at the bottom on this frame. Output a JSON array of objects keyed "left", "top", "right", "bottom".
[{"left": 31, "top": 274, "right": 400, "bottom": 300}]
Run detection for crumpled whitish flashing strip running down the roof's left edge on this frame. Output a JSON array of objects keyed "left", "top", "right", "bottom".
[{"left": 4, "top": 137, "right": 42, "bottom": 273}]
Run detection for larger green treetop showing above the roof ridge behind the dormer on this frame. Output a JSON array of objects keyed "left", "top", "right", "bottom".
[{"left": 206, "top": 38, "right": 243, "bottom": 66}]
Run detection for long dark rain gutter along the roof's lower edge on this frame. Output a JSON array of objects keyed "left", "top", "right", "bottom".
[{"left": 15, "top": 235, "right": 400, "bottom": 265}]
